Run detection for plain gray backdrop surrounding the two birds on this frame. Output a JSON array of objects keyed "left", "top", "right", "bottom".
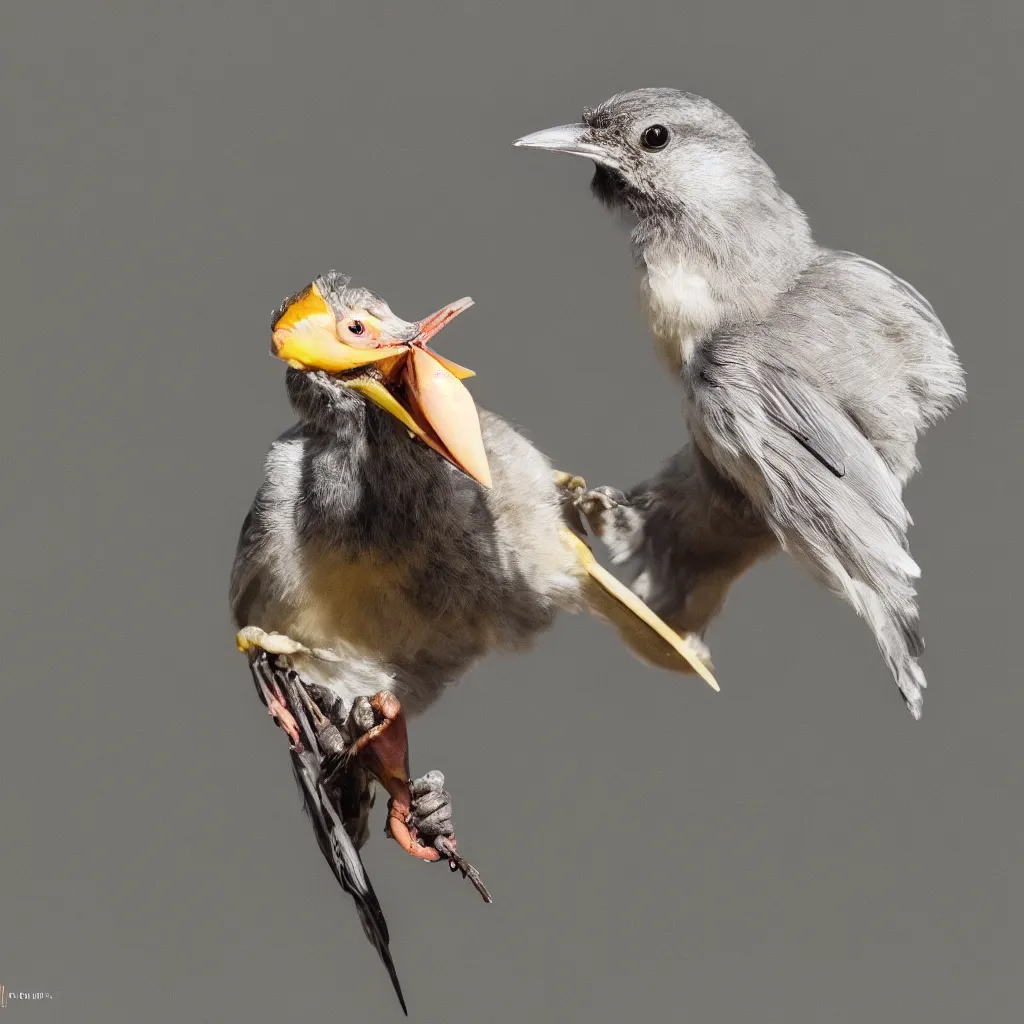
[{"left": 0, "top": 0, "right": 1024, "bottom": 1024}]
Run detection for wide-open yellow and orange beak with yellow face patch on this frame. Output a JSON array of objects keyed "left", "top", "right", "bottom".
[{"left": 272, "top": 285, "right": 492, "bottom": 487}]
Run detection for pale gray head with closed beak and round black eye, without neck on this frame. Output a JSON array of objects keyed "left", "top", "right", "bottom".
[{"left": 515, "top": 89, "right": 770, "bottom": 225}]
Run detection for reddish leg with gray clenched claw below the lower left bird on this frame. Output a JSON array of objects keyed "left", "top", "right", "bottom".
[{"left": 348, "top": 690, "right": 490, "bottom": 903}]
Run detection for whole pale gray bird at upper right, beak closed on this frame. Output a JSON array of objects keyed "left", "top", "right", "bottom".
[{"left": 515, "top": 89, "right": 965, "bottom": 718}]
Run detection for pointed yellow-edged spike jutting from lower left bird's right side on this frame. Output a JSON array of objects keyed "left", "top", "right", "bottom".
[{"left": 561, "top": 501, "right": 719, "bottom": 690}]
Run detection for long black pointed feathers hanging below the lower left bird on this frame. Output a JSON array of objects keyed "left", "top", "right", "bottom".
[{"left": 249, "top": 651, "right": 409, "bottom": 1016}]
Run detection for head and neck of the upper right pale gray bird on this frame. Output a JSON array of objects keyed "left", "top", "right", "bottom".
[{"left": 515, "top": 89, "right": 813, "bottom": 317}]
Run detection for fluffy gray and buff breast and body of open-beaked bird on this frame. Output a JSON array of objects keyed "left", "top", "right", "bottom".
[{"left": 232, "top": 403, "right": 579, "bottom": 696}]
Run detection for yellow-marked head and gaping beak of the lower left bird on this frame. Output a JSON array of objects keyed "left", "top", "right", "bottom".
[{"left": 271, "top": 270, "right": 490, "bottom": 487}]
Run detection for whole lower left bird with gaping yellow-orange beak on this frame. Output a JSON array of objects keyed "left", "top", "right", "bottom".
[{"left": 230, "top": 271, "right": 717, "bottom": 1010}]
